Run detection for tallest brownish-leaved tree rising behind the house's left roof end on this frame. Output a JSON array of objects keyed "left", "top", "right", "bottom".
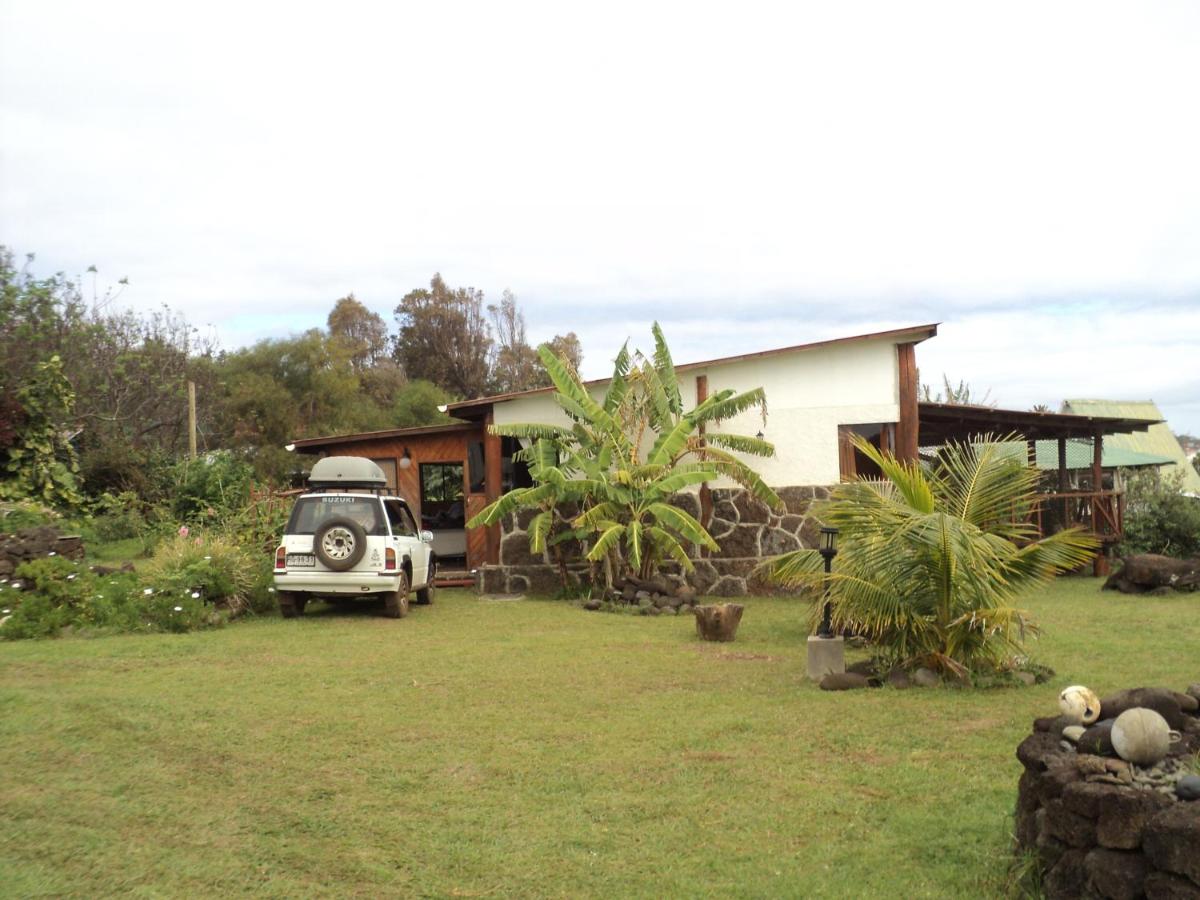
[{"left": 394, "top": 275, "right": 492, "bottom": 397}]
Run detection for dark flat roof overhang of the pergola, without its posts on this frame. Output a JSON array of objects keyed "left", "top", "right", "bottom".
[{"left": 917, "top": 403, "right": 1160, "bottom": 446}]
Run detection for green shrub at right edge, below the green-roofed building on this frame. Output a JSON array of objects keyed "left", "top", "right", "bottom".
[{"left": 1121, "top": 472, "right": 1200, "bottom": 558}]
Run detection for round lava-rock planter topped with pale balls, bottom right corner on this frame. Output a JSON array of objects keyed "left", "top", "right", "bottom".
[{"left": 1016, "top": 684, "right": 1200, "bottom": 900}]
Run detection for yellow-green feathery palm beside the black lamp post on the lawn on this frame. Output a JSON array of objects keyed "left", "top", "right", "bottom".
[{"left": 763, "top": 437, "right": 1098, "bottom": 677}]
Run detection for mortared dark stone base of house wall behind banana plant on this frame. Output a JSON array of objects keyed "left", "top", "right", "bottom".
[{"left": 479, "top": 485, "right": 829, "bottom": 596}]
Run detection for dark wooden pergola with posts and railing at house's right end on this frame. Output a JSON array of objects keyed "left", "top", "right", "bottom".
[{"left": 918, "top": 403, "right": 1160, "bottom": 575}]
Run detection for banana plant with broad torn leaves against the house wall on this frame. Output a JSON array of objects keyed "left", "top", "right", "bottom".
[{"left": 467, "top": 323, "right": 781, "bottom": 581}]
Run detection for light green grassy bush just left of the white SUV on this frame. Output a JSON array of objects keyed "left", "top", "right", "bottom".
[{"left": 143, "top": 528, "right": 260, "bottom": 614}]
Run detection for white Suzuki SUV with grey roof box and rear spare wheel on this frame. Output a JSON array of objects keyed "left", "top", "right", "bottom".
[{"left": 275, "top": 456, "right": 437, "bottom": 619}]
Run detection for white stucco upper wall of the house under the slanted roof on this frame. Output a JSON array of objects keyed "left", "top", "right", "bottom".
[{"left": 493, "top": 338, "right": 900, "bottom": 487}]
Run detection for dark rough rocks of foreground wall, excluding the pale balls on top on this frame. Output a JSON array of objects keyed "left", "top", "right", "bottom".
[{"left": 1015, "top": 685, "right": 1200, "bottom": 900}]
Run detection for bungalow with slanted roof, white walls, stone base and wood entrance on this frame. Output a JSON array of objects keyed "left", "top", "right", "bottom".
[{"left": 285, "top": 324, "right": 1151, "bottom": 595}]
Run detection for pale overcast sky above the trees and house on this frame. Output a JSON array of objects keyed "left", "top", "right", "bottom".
[{"left": 0, "top": 0, "right": 1200, "bottom": 433}]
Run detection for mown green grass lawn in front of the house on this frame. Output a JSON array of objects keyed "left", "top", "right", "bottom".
[{"left": 0, "top": 578, "right": 1200, "bottom": 898}]
